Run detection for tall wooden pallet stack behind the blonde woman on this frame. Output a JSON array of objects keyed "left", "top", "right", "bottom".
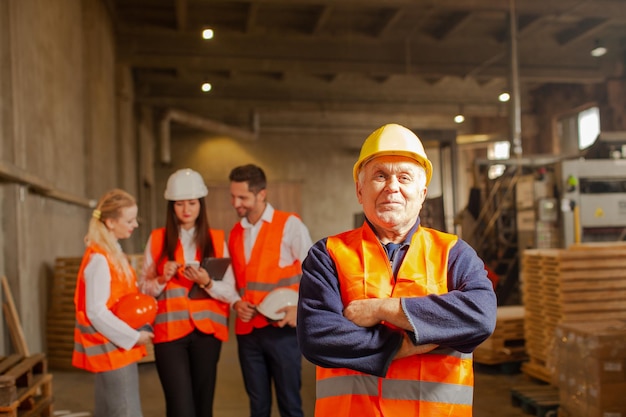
[{"left": 46, "top": 255, "right": 154, "bottom": 369}]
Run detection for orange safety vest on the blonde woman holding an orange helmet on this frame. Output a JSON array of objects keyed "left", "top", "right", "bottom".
[{"left": 72, "top": 244, "right": 146, "bottom": 372}]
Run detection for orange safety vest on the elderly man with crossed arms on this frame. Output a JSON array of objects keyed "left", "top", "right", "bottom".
[{"left": 315, "top": 226, "right": 474, "bottom": 417}]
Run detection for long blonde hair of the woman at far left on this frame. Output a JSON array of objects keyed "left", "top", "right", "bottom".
[{"left": 85, "top": 188, "right": 137, "bottom": 280}]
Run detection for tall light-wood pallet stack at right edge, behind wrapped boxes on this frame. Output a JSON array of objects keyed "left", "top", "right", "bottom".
[{"left": 521, "top": 243, "right": 626, "bottom": 382}]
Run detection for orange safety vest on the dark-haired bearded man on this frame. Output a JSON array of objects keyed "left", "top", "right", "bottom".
[{"left": 228, "top": 210, "right": 302, "bottom": 334}]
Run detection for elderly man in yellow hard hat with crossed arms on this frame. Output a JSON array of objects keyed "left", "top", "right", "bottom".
[{"left": 297, "top": 124, "right": 497, "bottom": 417}]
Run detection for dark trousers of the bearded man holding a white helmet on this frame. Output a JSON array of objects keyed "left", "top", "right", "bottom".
[{"left": 237, "top": 326, "right": 304, "bottom": 417}]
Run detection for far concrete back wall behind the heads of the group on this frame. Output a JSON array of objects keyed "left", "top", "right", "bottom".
[{"left": 148, "top": 129, "right": 367, "bottom": 244}]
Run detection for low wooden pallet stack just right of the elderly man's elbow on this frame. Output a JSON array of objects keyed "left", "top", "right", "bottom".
[{"left": 474, "top": 306, "right": 526, "bottom": 365}]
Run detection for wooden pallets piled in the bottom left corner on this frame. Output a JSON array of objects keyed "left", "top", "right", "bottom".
[{"left": 0, "top": 353, "right": 53, "bottom": 417}]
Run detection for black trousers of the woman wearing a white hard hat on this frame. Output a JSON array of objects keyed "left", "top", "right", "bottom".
[{"left": 154, "top": 329, "right": 222, "bottom": 417}]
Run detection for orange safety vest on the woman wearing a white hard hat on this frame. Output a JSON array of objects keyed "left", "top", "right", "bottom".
[{"left": 150, "top": 228, "right": 230, "bottom": 343}]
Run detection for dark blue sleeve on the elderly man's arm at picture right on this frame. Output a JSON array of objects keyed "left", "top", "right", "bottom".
[{"left": 402, "top": 239, "right": 497, "bottom": 353}]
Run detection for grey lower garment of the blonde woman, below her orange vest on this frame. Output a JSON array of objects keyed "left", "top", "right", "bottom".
[{"left": 93, "top": 363, "right": 143, "bottom": 417}]
